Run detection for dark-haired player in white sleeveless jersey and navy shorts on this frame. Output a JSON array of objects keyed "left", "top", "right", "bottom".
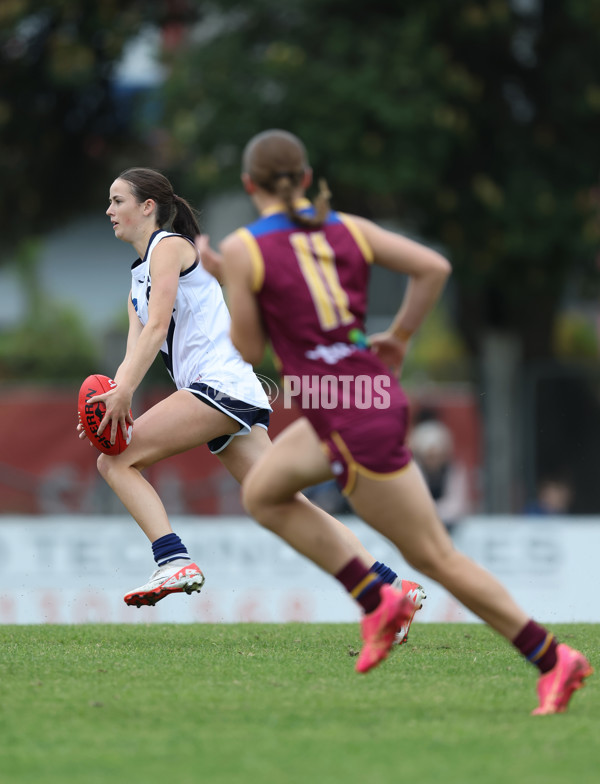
[{"left": 78, "top": 168, "right": 425, "bottom": 642}]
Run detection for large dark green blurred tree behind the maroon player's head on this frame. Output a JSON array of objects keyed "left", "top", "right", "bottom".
[{"left": 158, "top": 0, "right": 600, "bottom": 358}]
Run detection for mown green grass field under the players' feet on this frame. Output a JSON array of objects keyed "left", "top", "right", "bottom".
[{"left": 0, "top": 624, "right": 600, "bottom": 784}]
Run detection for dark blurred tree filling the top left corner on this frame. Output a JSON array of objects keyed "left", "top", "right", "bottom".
[{"left": 0, "top": 0, "right": 197, "bottom": 254}]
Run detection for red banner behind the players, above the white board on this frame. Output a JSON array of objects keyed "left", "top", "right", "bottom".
[{"left": 0, "top": 386, "right": 480, "bottom": 515}]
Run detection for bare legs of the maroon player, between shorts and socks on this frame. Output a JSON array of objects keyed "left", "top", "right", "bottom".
[{"left": 244, "top": 423, "right": 528, "bottom": 639}]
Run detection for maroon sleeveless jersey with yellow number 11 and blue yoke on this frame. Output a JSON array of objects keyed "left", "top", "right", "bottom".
[{"left": 238, "top": 201, "right": 407, "bottom": 442}]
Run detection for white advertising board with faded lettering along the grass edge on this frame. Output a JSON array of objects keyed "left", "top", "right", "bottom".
[{"left": 0, "top": 516, "right": 600, "bottom": 624}]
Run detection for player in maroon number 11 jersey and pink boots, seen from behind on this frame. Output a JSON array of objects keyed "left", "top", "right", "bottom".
[{"left": 196, "top": 130, "right": 592, "bottom": 714}]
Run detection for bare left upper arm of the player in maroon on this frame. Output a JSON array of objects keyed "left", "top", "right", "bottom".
[{"left": 220, "top": 234, "right": 267, "bottom": 365}]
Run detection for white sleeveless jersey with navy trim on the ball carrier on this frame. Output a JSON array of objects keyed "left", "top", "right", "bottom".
[{"left": 131, "top": 231, "right": 271, "bottom": 410}]
